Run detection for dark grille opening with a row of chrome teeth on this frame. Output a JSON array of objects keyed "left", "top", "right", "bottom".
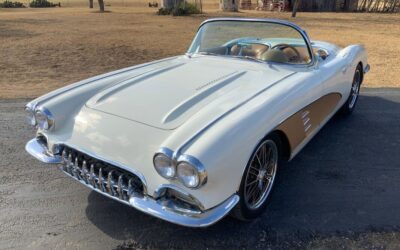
[{"left": 62, "top": 146, "right": 144, "bottom": 201}]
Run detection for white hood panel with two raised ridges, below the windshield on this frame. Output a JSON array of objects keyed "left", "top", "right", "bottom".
[{"left": 86, "top": 56, "right": 293, "bottom": 130}]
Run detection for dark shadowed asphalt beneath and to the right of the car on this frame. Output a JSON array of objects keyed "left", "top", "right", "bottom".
[{"left": 86, "top": 90, "right": 400, "bottom": 248}]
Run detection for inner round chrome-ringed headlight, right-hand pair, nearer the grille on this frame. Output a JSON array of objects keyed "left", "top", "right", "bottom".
[{"left": 153, "top": 148, "right": 176, "bottom": 179}]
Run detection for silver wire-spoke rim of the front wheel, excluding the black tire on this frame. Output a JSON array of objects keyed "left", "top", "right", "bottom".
[{"left": 244, "top": 140, "right": 278, "bottom": 210}]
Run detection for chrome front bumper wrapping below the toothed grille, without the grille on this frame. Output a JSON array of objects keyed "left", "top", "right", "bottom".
[{"left": 25, "top": 138, "right": 239, "bottom": 227}]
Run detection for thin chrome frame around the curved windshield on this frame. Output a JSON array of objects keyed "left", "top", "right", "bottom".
[{"left": 186, "top": 17, "right": 317, "bottom": 67}]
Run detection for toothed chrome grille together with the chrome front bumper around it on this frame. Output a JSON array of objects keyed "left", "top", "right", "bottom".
[{"left": 26, "top": 138, "right": 244, "bottom": 227}]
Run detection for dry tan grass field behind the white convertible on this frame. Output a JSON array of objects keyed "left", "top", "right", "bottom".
[{"left": 0, "top": 5, "right": 400, "bottom": 98}]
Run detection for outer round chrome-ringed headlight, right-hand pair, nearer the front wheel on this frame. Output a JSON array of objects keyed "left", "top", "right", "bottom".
[{"left": 176, "top": 155, "right": 207, "bottom": 189}]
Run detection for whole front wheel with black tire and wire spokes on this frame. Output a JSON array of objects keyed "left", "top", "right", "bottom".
[{"left": 232, "top": 135, "right": 280, "bottom": 220}]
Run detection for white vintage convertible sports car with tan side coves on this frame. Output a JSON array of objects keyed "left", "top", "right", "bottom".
[{"left": 26, "top": 18, "right": 369, "bottom": 227}]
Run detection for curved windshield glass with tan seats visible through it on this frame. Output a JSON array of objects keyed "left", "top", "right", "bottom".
[{"left": 188, "top": 20, "right": 311, "bottom": 64}]
